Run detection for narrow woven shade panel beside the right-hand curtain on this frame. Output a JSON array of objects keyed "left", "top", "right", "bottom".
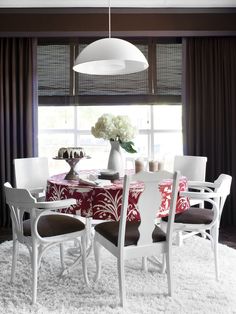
[{"left": 156, "top": 44, "right": 182, "bottom": 95}]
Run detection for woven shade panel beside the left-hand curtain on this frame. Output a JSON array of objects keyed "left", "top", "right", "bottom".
[{"left": 37, "top": 45, "right": 70, "bottom": 96}]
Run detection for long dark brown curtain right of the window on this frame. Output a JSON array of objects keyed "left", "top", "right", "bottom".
[{"left": 183, "top": 37, "right": 236, "bottom": 225}]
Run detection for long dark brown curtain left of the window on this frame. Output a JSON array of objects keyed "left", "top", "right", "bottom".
[{"left": 0, "top": 38, "right": 37, "bottom": 227}]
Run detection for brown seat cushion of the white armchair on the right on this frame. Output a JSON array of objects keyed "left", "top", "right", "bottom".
[{"left": 162, "top": 207, "right": 214, "bottom": 224}]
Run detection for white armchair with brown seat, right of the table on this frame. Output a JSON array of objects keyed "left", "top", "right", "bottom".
[{"left": 161, "top": 174, "right": 232, "bottom": 280}]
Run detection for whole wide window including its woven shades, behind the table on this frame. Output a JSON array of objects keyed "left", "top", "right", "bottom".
[{"left": 37, "top": 38, "right": 183, "bottom": 172}]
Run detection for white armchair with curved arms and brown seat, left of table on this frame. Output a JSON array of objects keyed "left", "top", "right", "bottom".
[{"left": 4, "top": 182, "right": 89, "bottom": 304}]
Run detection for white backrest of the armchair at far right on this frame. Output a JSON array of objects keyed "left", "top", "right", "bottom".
[{"left": 214, "top": 173, "right": 232, "bottom": 216}]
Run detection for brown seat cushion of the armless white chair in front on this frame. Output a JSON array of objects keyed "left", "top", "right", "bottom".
[{"left": 95, "top": 221, "right": 166, "bottom": 246}]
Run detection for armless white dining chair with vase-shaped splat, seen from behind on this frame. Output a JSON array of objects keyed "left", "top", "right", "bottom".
[{"left": 94, "top": 171, "right": 180, "bottom": 306}]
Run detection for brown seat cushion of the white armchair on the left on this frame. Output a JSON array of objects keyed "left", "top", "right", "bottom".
[{"left": 23, "top": 215, "right": 85, "bottom": 237}]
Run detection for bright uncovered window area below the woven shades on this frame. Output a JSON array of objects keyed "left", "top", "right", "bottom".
[{"left": 38, "top": 104, "right": 182, "bottom": 172}]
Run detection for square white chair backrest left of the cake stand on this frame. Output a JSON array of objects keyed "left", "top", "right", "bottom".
[{"left": 14, "top": 157, "right": 49, "bottom": 190}]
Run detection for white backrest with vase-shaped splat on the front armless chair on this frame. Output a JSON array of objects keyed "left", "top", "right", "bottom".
[{"left": 118, "top": 171, "right": 180, "bottom": 248}]
